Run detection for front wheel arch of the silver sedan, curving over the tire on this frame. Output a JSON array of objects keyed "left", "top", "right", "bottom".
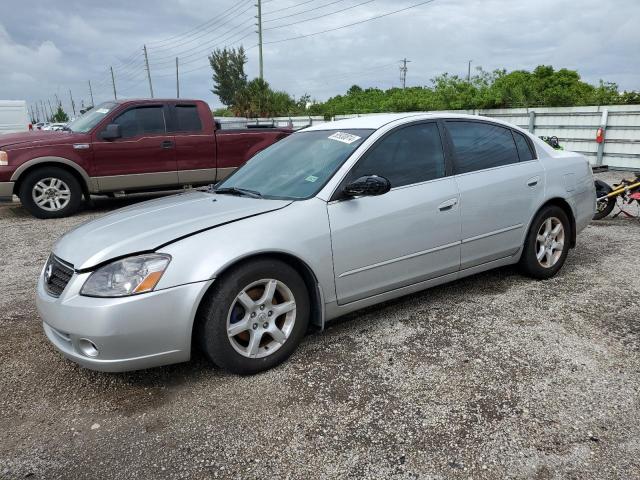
[{"left": 191, "top": 251, "right": 325, "bottom": 346}]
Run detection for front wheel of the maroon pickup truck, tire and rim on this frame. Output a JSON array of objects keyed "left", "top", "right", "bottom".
[{"left": 18, "top": 167, "right": 82, "bottom": 219}]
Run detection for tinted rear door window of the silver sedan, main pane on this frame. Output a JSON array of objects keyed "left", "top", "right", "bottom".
[{"left": 446, "top": 121, "right": 519, "bottom": 174}]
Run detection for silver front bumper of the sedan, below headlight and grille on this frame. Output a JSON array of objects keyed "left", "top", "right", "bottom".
[{"left": 36, "top": 273, "right": 212, "bottom": 372}]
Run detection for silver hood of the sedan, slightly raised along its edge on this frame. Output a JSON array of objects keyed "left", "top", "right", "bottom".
[{"left": 53, "top": 191, "right": 291, "bottom": 270}]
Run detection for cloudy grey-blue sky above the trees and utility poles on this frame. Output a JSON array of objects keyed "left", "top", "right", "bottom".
[{"left": 0, "top": 0, "right": 640, "bottom": 117}]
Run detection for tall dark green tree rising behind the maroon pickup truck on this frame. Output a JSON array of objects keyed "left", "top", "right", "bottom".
[{"left": 209, "top": 46, "right": 247, "bottom": 107}]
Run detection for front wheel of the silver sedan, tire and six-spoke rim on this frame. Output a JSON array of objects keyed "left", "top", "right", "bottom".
[{"left": 196, "top": 259, "right": 310, "bottom": 375}]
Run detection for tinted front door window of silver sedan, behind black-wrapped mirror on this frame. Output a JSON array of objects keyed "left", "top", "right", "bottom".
[{"left": 349, "top": 122, "right": 445, "bottom": 187}]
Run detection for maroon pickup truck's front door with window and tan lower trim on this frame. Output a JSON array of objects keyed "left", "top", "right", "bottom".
[{"left": 93, "top": 104, "right": 178, "bottom": 191}]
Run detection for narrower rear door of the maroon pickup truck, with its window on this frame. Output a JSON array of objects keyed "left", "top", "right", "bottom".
[{"left": 170, "top": 103, "right": 216, "bottom": 185}]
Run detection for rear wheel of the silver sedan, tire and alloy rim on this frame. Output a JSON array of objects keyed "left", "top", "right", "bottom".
[{"left": 519, "top": 205, "right": 571, "bottom": 280}]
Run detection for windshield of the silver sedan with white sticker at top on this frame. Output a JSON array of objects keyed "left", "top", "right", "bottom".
[{"left": 215, "top": 129, "right": 373, "bottom": 200}]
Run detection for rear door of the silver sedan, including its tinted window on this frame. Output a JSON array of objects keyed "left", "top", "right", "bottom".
[{"left": 445, "top": 120, "right": 544, "bottom": 270}]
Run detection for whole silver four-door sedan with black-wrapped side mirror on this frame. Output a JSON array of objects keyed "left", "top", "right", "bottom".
[{"left": 37, "top": 114, "right": 595, "bottom": 374}]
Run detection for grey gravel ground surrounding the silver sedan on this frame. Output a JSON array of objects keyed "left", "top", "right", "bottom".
[{"left": 0, "top": 174, "right": 640, "bottom": 479}]
